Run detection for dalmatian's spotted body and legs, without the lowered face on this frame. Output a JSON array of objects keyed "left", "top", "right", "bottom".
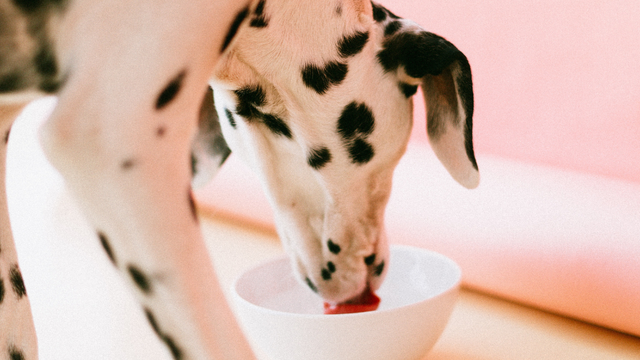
[{"left": 0, "top": 0, "right": 255, "bottom": 360}]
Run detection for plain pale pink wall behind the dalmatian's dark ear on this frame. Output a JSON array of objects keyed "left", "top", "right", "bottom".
[{"left": 381, "top": 0, "right": 640, "bottom": 182}]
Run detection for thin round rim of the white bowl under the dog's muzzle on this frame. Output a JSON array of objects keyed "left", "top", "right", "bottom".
[{"left": 231, "top": 244, "right": 462, "bottom": 320}]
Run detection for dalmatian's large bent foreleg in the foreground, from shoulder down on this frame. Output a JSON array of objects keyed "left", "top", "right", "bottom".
[{"left": 41, "top": 0, "right": 254, "bottom": 360}]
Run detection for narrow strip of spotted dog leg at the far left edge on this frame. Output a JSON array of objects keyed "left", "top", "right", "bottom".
[{"left": 0, "top": 105, "right": 38, "bottom": 360}]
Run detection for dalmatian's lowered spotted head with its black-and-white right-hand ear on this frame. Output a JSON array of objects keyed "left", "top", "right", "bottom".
[{"left": 211, "top": 0, "right": 479, "bottom": 302}]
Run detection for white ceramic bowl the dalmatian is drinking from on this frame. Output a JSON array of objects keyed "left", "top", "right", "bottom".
[{"left": 233, "top": 246, "right": 461, "bottom": 360}]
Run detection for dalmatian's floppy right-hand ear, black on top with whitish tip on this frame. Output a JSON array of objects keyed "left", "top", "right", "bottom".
[{"left": 378, "top": 25, "right": 480, "bottom": 189}]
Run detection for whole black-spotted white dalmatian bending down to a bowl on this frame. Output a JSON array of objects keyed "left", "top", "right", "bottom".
[{"left": 0, "top": 0, "right": 479, "bottom": 360}]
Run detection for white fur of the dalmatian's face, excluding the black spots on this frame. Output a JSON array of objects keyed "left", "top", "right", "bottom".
[{"left": 211, "top": 0, "right": 470, "bottom": 302}]
